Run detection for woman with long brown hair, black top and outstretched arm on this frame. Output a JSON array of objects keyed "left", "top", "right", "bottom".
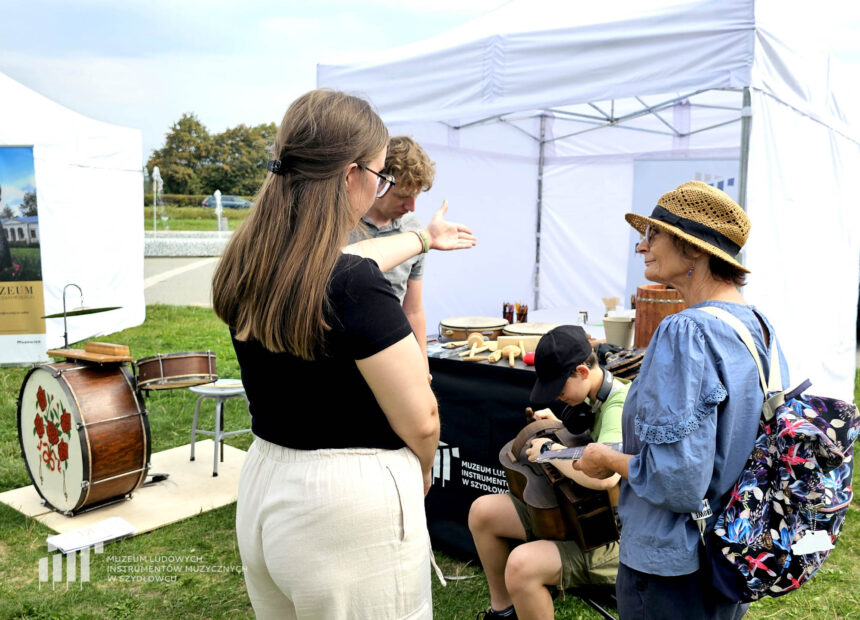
[{"left": 213, "top": 90, "right": 474, "bottom": 619}]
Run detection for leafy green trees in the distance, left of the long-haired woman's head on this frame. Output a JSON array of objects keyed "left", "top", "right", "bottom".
[{"left": 146, "top": 114, "right": 277, "bottom": 196}]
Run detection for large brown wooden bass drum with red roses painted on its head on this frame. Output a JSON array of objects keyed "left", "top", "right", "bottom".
[{"left": 18, "top": 362, "right": 151, "bottom": 516}]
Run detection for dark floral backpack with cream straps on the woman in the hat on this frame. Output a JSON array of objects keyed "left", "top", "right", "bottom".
[{"left": 692, "top": 306, "right": 860, "bottom": 602}]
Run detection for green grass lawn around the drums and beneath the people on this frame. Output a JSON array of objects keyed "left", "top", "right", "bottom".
[{"left": 0, "top": 308, "right": 860, "bottom": 620}]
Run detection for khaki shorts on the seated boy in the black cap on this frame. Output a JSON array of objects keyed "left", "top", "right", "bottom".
[{"left": 509, "top": 494, "right": 618, "bottom": 590}]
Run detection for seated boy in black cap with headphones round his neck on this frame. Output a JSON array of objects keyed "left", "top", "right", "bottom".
[{"left": 469, "top": 325, "right": 630, "bottom": 620}]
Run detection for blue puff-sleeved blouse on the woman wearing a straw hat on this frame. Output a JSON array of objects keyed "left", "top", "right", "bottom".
[{"left": 618, "top": 301, "right": 788, "bottom": 576}]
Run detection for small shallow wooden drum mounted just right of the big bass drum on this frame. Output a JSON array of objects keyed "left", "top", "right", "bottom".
[{"left": 134, "top": 351, "right": 218, "bottom": 390}]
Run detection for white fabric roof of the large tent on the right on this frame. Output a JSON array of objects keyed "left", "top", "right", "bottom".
[{"left": 317, "top": 0, "right": 860, "bottom": 141}]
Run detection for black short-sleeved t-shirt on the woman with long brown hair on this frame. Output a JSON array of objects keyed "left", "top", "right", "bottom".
[{"left": 231, "top": 254, "right": 412, "bottom": 450}]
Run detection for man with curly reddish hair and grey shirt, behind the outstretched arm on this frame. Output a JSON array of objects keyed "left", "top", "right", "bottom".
[{"left": 350, "top": 136, "right": 436, "bottom": 359}]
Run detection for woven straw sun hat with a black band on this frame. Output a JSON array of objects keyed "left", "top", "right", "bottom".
[{"left": 624, "top": 181, "right": 750, "bottom": 273}]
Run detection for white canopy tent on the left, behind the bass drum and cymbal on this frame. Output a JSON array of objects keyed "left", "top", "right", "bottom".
[{"left": 0, "top": 74, "right": 146, "bottom": 361}]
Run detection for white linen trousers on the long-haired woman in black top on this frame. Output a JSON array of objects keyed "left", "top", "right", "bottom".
[{"left": 236, "top": 437, "right": 433, "bottom": 620}]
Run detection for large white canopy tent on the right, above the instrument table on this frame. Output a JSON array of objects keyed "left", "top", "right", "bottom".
[{"left": 318, "top": 0, "right": 860, "bottom": 398}]
